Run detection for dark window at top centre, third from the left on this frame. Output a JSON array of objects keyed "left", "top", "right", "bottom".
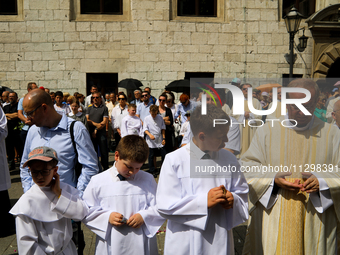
[{"left": 177, "top": 0, "right": 217, "bottom": 17}]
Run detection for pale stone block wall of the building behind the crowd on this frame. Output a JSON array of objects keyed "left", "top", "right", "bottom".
[{"left": 0, "top": 0, "right": 337, "bottom": 95}]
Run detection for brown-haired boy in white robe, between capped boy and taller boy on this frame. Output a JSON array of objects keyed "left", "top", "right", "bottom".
[{"left": 83, "top": 135, "right": 164, "bottom": 255}]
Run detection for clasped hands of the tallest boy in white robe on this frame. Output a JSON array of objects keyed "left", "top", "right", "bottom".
[{"left": 208, "top": 185, "right": 234, "bottom": 209}]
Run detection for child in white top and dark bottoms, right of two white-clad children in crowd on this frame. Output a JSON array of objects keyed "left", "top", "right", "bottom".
[{"left": 143, "top": 105, "right": 166, "bottom": 177}]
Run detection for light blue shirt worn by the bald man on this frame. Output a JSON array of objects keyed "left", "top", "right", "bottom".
[{"left": 20, "top": 114, "right": 99, "bottom": 195}]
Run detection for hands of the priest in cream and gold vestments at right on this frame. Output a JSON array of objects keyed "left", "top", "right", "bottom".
[{"left": 275, "top": 172, "right": 319, "bottom": 193}]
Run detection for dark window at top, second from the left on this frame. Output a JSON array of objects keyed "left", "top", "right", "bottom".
[{"left": 80, "top": 0, "right": 123, "bottom": 15}]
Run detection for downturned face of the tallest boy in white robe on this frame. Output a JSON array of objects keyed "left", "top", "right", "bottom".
[{"left": 198, "top": 128, "right": 229, "bottom": 151}]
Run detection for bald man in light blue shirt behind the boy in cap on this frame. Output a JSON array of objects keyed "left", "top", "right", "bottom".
[{"left": 20, "top": 89, "right": 98, "bottom": 194}]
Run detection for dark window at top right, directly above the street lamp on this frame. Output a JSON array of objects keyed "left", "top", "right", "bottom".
[{"left": 282, "top": 0, "right": 315, "bottom": 18}]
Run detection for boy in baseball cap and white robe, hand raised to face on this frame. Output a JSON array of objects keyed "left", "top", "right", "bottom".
[{"left": 10, "top": 146, "right": 88, "bottom": 254}]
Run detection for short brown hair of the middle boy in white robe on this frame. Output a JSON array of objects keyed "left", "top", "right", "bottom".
[{"left": 116, "top": 135, "right": 149, "bottom": 163}]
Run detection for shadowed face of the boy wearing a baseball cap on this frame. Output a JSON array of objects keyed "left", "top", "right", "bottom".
[{"left": 28, "top": 160, "right": 58, "bottom": 187}]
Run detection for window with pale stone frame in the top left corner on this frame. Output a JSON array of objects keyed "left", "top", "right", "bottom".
[{"left": 0, "top": 0, "right": 24, "bottom": 21}]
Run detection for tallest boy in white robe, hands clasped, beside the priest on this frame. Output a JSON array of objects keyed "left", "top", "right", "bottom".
[{"left": 156, "top": 104, "right": 248, "bottom": 255}]
